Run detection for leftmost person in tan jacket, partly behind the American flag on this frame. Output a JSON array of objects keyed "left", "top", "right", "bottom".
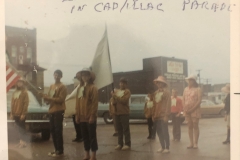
[{"left": 10, "top": 78, "right": 29, "bottom": 148}]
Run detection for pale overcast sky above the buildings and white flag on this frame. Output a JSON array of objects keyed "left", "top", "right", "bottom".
[{"left": 5, "top": 0, "right": 234, "bottom": 85}]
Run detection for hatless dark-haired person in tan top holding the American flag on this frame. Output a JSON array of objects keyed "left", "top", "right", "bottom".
[{"left": 42, "top": 70, "right": 67, "bottom": 157}]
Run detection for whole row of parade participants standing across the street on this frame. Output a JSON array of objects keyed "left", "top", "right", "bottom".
[{"left": 11, "top": 68, "right": 230, "bottom": 160}]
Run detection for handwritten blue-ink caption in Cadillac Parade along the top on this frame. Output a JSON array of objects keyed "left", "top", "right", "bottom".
[{"left": 62, "top": 0, "right": 236, "bottom": 13}]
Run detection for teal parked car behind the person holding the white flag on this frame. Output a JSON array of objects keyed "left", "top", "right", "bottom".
[{"left": 98, "top": 94, "right": 185, "bottom": 124}]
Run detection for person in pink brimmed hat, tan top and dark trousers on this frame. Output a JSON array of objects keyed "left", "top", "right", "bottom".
[{"left": 152, "top": 76, "right": 171, "bottom": 153}]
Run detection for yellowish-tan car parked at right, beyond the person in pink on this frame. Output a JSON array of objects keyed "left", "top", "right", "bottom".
[{"left": 201, "top": 100, "right": 225, "bottom": 116}]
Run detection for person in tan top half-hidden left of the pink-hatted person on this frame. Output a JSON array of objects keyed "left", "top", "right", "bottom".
[{"left": 144, "top": 94, "right": 153, "bottom": 139}]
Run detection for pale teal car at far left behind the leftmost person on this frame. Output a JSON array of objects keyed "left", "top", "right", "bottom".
[{"left": 7, "top": 89, "right": 50, "bottom": 140}]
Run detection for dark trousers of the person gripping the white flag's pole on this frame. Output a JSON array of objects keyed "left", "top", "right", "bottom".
[{"left": 115, "top": 114, "right": 131, "bottom": 146}]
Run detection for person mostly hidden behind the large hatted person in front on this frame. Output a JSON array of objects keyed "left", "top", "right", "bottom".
[{"left": 72, "top": 72, "right": 83, "bottom": 142}]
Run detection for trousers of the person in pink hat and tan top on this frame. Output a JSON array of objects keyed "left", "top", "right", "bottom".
[{"left": 155, "top": 120, "right": 170, "bottom": 149}]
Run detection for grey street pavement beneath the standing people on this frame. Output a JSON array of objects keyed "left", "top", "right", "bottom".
[{"left": 8, "top": 117, "right": 230, "bottom": 160}]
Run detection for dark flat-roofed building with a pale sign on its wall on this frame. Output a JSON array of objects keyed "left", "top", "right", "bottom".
[{"left": 99, "top": 56, "right": 188, "bottom": 103}]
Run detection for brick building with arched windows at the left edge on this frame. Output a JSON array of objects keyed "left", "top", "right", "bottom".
[{"left": 5, "top": 26, "right": 45, "bottom": 104}]
